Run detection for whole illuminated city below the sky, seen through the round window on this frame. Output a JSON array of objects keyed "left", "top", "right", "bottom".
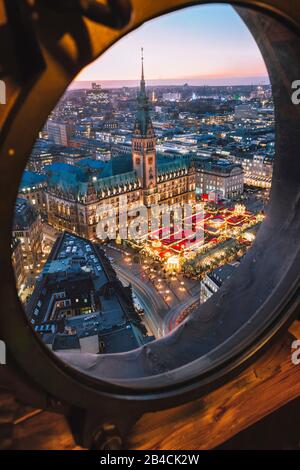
[{"left": 12, "top": 38, "right": 274, "bottom": 354}]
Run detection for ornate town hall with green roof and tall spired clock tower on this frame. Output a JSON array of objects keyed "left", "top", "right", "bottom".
[{"left": 46, "top": 53, "right": 196, "bottom": 240}]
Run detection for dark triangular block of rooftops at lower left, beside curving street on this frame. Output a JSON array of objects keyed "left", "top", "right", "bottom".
[{"left": 26, "top": 232, "right": 146, "bottom": 352}]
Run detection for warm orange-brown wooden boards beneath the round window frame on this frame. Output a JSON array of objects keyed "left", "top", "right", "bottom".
[{"left": 10, "top": 322, "right": 300, "bottom": 450}]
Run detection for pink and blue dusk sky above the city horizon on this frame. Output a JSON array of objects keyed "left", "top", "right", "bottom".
[{"left": 73, "top": 5, "right": 268, "bottom": 87}]
